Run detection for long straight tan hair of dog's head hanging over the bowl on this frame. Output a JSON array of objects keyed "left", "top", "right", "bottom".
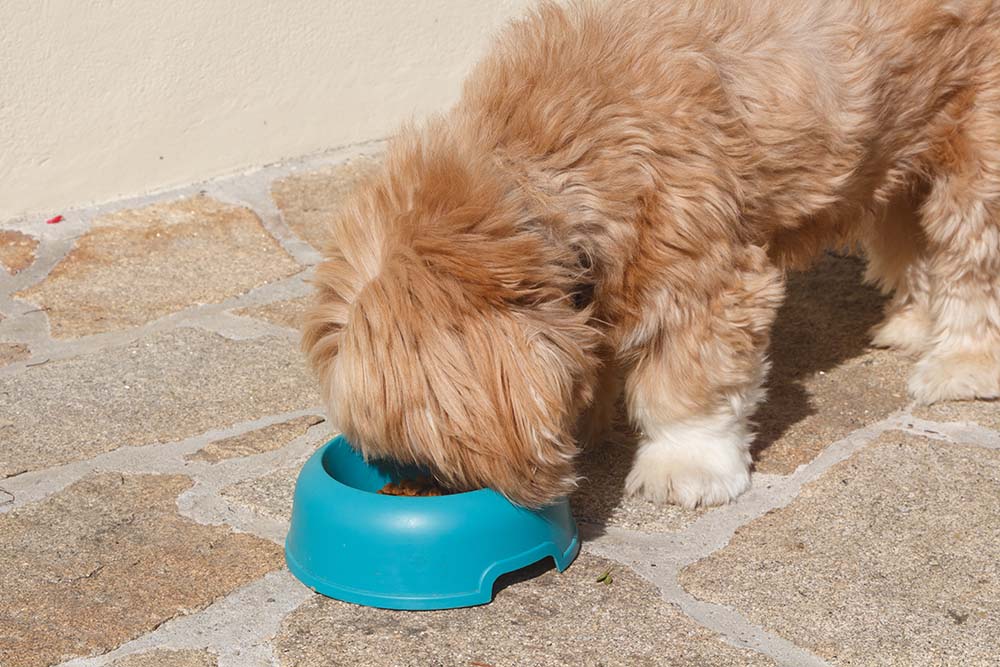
[{"left": 332, "top": 281, "right": 595, "bottom": 506}]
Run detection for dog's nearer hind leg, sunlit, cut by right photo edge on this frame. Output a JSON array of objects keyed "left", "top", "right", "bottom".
[{"left": 909, "top": 86, "right": 1000, "bottom": 403}]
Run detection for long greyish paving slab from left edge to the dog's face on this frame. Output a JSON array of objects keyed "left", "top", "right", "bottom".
[{"left": 0, "top": 329, "right": 320, "bottom": 478}]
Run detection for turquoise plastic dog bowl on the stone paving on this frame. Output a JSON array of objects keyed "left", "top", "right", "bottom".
[{"left": 285, "top": 436, "right": 580, "bottom": 609}]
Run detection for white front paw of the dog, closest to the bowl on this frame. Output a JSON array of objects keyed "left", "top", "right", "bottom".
[{"left": 625, "top": 418, "right": 751, "bottom": 508}]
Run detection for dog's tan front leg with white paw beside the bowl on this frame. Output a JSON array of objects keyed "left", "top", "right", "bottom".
[{"left": 624, "top": 247, "right": 784, "bottom": 507}]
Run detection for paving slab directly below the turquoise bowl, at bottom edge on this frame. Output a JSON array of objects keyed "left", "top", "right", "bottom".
[{"left": 274, "top": 555, "right": 774, "bottom": 667}]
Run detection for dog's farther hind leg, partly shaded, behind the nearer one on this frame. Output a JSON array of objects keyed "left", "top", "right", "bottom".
[{"left": 863, "top": 192, "right": 933, "bottom": 354}]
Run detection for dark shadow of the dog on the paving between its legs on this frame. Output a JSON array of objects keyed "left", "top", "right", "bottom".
[{"left": 572, "top": 253, "right": 885, "bottom": 535}]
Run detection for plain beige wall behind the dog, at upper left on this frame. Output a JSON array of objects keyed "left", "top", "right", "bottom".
[{"left": 0, "top": 0, "right": 527, "bottom": 219}]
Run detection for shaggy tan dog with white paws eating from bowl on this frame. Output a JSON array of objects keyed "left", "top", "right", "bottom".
[{"left": 303, "top": 0, "right": 1000, "bottom": 507}]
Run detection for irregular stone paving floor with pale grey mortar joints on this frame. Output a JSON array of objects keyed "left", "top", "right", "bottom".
[{"left": 0, "top": 145, "right": 1000, "bottom": 667}]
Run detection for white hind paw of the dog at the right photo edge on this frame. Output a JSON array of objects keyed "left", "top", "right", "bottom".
[{"left": 909, "top": 352, "right": 1000, "bottom": 405}]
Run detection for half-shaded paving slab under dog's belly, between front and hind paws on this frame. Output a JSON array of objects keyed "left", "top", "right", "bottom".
[{"left": 754, "top": 254, "right": 912, "bottom": 474}]
